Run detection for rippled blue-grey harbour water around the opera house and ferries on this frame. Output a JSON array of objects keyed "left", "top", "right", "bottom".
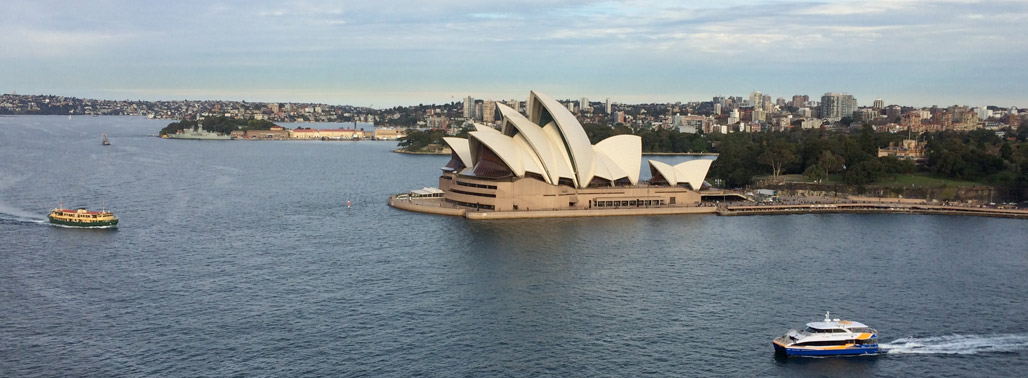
[{"left": 0, "top": 116, "right": 1028, "bottom": 377}]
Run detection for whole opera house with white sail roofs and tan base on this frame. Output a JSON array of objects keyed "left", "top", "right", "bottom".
[{"left": 389, "top": 91, "right": 717, "bottom": 219}]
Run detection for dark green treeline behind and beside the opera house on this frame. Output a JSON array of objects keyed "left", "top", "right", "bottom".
[{"left": 399, "top": 123, "right": 1028, "bottom": 192}]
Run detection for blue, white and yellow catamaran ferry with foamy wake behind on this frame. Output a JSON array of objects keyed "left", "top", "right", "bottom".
[{"left": 772, "top": 312, "right": 880, "bottom": 356}]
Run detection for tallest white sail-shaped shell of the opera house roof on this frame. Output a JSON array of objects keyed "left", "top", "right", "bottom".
[{"left": 528, "top": 90, "right": 595, "bottom": 187}]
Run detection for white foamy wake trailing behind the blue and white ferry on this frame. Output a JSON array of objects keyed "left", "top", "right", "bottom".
[{"left": 879, "top": 334, "right": 1028, "bottom": 354}]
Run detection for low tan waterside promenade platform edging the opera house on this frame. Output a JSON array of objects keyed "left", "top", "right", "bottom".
[{"left": 389, "top": 195, "right": 718, "bottom": 219}]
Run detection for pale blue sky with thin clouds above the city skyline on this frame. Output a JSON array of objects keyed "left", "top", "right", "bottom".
[{"left": 0, "top": 0, "right": 1028, "bottom": 108}]
